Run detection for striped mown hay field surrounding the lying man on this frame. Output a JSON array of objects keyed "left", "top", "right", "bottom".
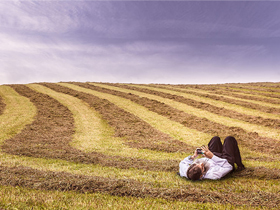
[{"left": 0, "top": 82, "right": 280, "bottom": 209}]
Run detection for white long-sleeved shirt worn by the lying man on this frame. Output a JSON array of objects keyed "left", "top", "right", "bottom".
[{"left": 179, "top": 155, "right": 233, "bottom": 180}]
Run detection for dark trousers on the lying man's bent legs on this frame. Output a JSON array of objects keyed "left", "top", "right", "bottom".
[{"left": 208, "top": 136, "right": 244, "bottom": 168}]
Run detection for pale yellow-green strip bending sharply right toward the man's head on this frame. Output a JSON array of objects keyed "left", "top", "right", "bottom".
[{"left": 28, "top": 84, "right": 185, "bottom": 160}]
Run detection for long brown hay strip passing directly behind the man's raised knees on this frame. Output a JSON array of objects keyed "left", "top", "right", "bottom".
[{"left": 68, "top": 83, "right": 280, "bottom": 161}]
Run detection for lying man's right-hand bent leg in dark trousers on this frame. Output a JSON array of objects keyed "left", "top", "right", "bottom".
[{"left": 223, "top": 136, "right": 244, "bottom": 169}]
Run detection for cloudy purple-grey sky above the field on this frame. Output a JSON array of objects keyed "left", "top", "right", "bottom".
[{"left": 0, "top": 0, "right": 280, "bottom": 84}]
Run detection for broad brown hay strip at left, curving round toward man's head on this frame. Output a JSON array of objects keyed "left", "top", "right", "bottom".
[{"left": 2, "top": 85, "right": 178, "bottom": 171}]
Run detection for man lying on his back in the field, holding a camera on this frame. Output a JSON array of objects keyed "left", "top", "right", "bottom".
[{"left": 179, "top": 136, "right": 245, "bottom": 181}]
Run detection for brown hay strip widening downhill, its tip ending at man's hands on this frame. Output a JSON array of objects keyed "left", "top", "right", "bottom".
[{"left": 43, "top": 83, "right": 195, "bottom": 152}]
